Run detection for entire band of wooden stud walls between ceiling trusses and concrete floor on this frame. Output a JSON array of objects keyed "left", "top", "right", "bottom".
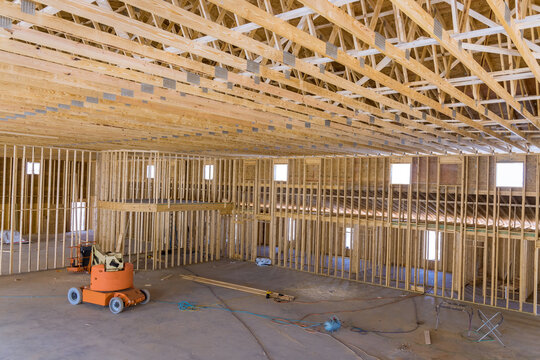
[{"left": 4, "top": 146, "right": 540, "bottom": 313}]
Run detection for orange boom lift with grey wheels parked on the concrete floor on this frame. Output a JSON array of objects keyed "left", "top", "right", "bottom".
[{"left": 68, "top": 245, "right": 150, "bottom": 314}]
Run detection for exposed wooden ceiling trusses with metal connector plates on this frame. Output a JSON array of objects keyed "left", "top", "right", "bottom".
[{"left": 0, "top": 0, "right": 540, "bottom": 155}]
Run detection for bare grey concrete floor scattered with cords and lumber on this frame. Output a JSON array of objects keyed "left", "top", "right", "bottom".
[{"left": 0, "top": 261, "right": 540, "bottom": 360}]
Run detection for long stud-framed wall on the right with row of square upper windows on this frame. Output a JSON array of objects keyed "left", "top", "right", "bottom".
[{"left": 229, "top": 155, "right": 540, "bottom": 313}]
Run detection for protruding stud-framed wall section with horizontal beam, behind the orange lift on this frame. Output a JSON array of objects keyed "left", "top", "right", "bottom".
[{"left": 96, "top": 151, "right": 236, "bottom": 269}]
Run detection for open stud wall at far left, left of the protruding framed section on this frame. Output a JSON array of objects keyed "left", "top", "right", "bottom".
[{"left": 0, "top": 145, "right": 96, "bottom": 275}]
